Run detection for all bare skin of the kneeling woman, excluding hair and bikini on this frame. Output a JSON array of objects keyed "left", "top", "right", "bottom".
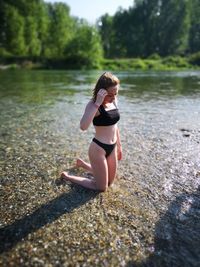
[{"left": 61, "top": 82, "right": 121, "bottom": 191}]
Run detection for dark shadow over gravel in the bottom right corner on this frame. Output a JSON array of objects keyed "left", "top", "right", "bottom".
[{"left": 127, "top": 188, "right": 200, "bottom": 267}]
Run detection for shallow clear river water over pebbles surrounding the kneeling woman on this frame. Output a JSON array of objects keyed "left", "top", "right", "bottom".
[{"left": 0, "top": 71, "right": 200, "bottom": 266}]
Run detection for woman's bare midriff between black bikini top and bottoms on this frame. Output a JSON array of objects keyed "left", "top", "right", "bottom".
[{"left": 95, "top": 124, "right": 117, "bottom": 144}]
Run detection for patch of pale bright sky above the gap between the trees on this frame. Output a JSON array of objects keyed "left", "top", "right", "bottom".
[{"left": 45, "top": 0, "right": 134, "bottom": 23}]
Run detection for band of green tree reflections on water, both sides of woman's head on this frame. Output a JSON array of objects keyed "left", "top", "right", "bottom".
[{"left": 0, "top": 70, "right": 200, "bottom": 104}]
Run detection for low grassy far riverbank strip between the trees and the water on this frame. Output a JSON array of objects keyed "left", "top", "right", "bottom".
[{"left": 0, "top": 53, "right": 200, "bottom": 71}]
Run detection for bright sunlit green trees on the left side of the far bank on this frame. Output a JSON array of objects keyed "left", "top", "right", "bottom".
[{"left": 0, "top": 0, "right": 103, "bottom": 68}]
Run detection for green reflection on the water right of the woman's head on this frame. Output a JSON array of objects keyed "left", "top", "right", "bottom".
[{"left": 120, "top": 74, "right": 200, "bottom": 99}]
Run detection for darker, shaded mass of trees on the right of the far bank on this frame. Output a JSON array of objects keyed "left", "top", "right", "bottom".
[{"left": 98, "top": 0, "right": 200, "bottom": 58}]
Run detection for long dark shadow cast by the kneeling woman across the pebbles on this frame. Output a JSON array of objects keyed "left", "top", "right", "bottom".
[{"left": 0, "top": 181, "right": 98, "bottom": 254}]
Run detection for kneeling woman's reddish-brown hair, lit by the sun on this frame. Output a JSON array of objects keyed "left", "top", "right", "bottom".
[{"left": 92, "top": 72, "right": 120, "bottom": 102}]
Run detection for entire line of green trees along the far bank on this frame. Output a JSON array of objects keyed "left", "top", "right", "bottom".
[{"left": 0, "top": 0, "right": 200, "bottom": 68}]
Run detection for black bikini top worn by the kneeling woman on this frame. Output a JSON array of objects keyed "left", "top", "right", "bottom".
[{"left": 93, "top": 105, "right": 120, "bottom": 126}]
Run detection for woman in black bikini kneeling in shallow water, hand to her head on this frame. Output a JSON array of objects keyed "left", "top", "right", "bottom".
[{"left": 61, "top": 72, "right": 122, "bottom": 191}]
